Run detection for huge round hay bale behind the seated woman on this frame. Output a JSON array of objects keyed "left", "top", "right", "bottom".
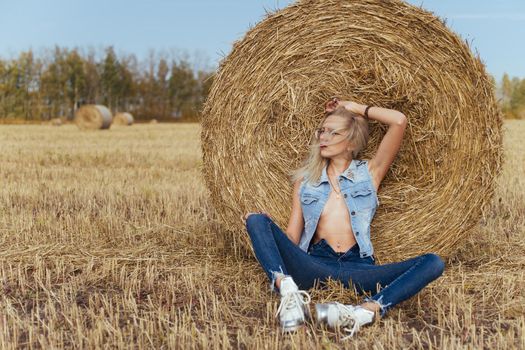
[{"left": 201, "top": 0, "right": 502, "bottom": 261}]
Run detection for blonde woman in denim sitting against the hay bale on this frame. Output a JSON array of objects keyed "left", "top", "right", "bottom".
[{"left": 243, "top": 98, "right": 444, "bottom": 336}]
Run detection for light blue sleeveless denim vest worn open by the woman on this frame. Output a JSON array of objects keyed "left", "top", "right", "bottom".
[{"left": 299, "top": 159, "right": 379, "bottom": 258}]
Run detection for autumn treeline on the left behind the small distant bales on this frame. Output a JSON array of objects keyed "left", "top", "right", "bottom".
[{"left": 0, "top": 47, "right": 213, "bottom": 121}]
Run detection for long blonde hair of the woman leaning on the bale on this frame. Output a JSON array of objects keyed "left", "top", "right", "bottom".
[{"left": 291, "top": 106, "right": 369, "bottom": 183}]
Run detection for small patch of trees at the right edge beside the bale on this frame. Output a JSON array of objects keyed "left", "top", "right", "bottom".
[{"left": 498, "top": 73, "right": 525, "bottom": 119}]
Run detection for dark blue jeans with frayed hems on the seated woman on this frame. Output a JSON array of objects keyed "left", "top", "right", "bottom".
[{"left": 246, "top": 214, "right": 445, "bottom": 315}]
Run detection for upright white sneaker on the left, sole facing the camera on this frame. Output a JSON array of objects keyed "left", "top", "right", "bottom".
[{"left": 277, "top": 276, "right": 310, "bottom": 332}]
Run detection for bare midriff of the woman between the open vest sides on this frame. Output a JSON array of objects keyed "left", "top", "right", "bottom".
[{"left": 312, "top": 191, "right": 356, "bottom": 253}]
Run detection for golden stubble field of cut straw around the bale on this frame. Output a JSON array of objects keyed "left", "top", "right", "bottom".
[{"left": 0, "top": 121, "right": 525, "bottom": 349}]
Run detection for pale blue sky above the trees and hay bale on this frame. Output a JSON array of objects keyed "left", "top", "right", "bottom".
[{"left": 0, "top": 0, "right": 525, "bottom": 80}]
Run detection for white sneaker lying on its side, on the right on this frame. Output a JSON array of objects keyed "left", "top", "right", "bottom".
[{"left": 315, "top": 302, "right": 375, "bottom": 340}]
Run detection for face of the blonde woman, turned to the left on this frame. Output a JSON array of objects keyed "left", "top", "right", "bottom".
[{"left": 319, "top": 115, "right": 353, "bottom": 158}]
